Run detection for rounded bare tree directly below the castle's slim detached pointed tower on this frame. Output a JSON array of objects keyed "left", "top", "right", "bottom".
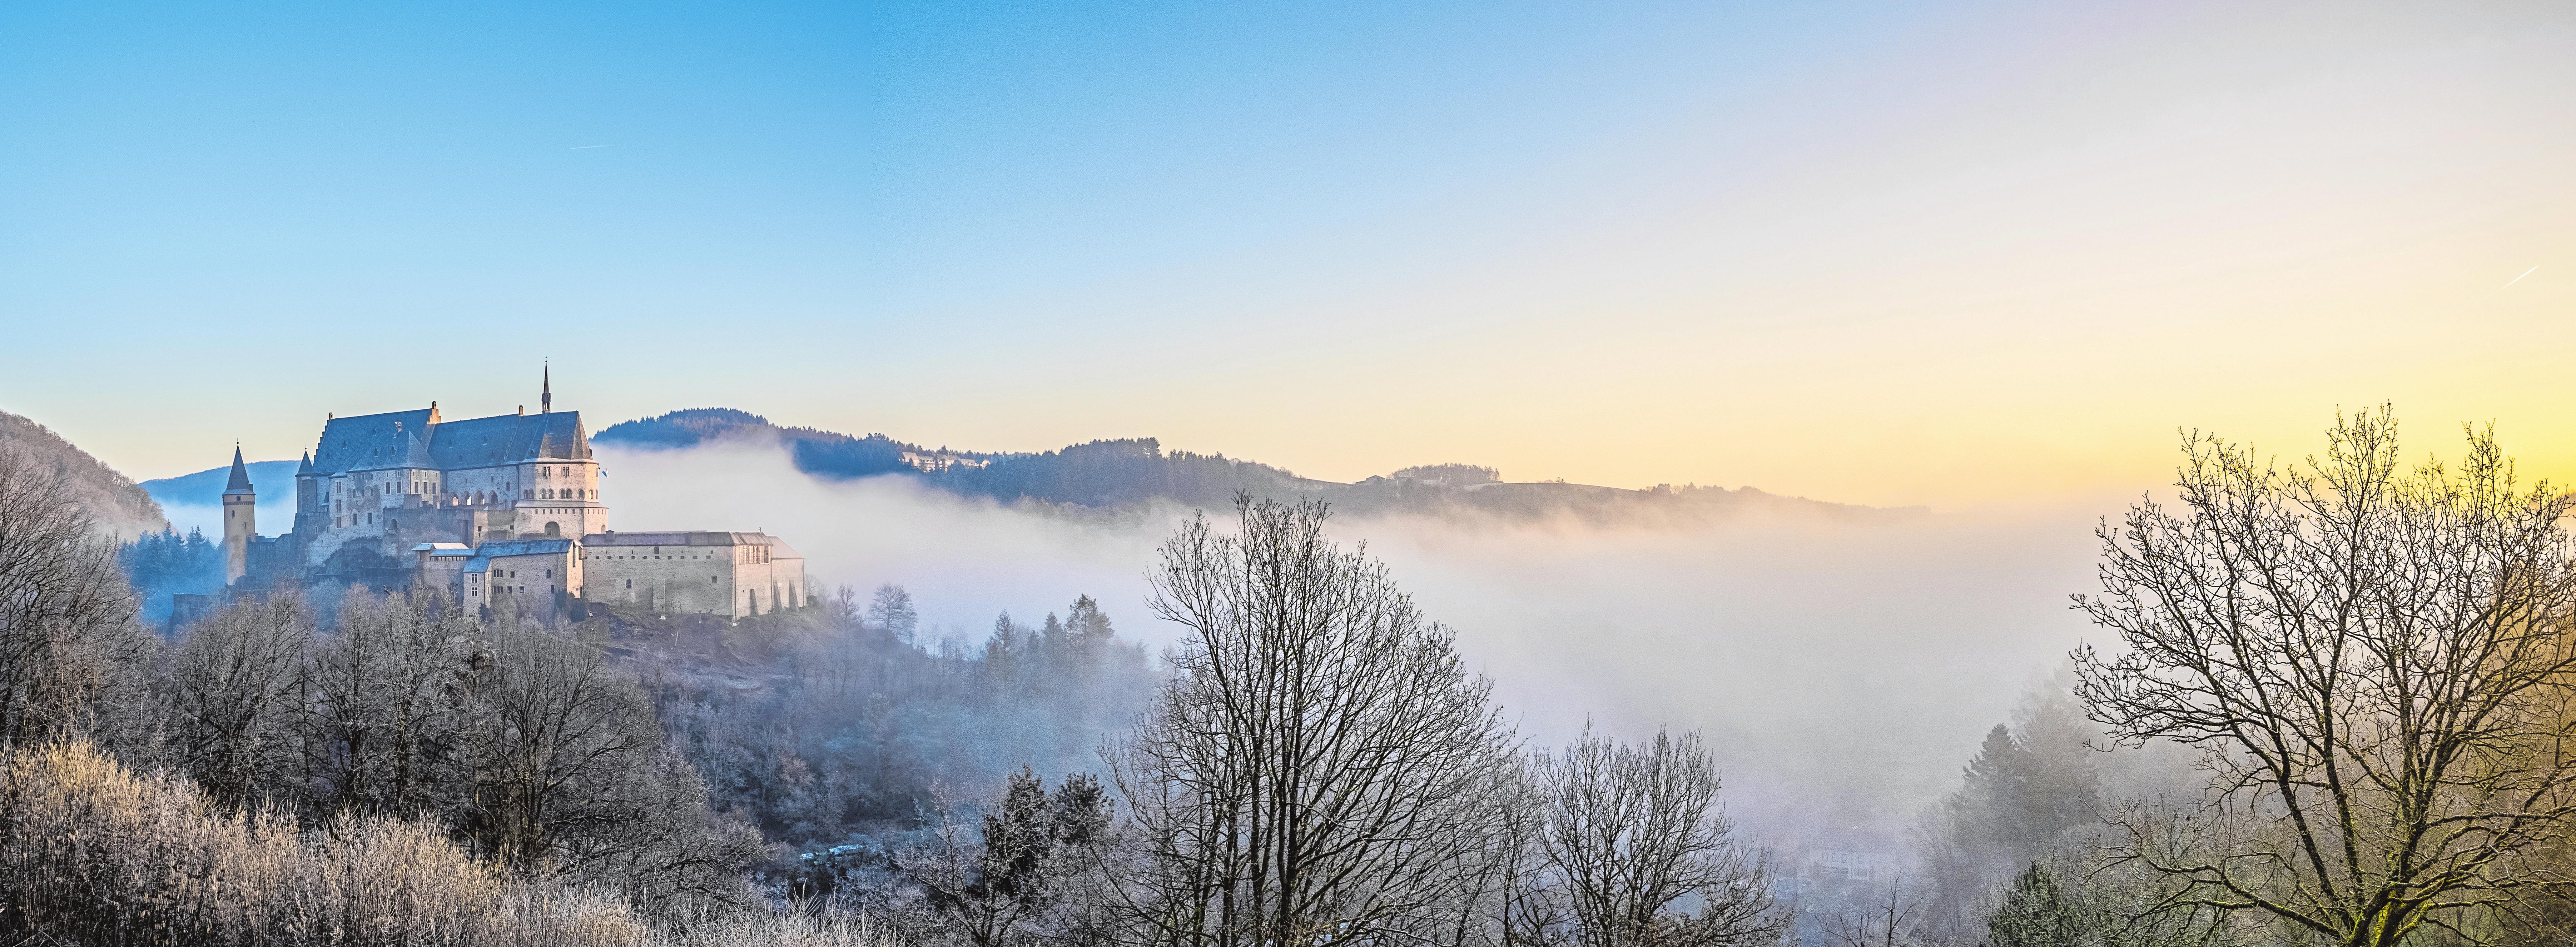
[{"left": 165, "top": 592, "right": 314, "bottom": 806}]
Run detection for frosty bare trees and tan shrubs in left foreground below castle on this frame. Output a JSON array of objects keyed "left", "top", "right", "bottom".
[{"left": 0, "top": 453, "right": 858, "bottom": 944}]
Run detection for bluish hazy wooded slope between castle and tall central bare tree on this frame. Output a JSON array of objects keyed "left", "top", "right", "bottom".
[{"left": 646, "top": 587, "right": 1157, "bottom": 847}]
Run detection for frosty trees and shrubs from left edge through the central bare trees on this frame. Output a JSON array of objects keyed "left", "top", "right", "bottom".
[{"left": 0, "top": 422, "right": 1785, "bottom": 947}]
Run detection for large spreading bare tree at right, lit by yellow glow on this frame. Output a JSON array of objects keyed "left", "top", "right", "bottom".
[{"left": 2076, "top": 407, "right": 2576, "bottom": 947}]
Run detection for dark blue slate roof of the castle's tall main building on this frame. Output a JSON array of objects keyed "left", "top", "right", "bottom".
[{"left": 312, "top": 409, "right": 590, "bottom": 476}]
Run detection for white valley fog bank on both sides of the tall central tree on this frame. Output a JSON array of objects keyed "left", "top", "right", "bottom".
[{"left": 597, "top": 445, "right": 2115, "bottom": 842}]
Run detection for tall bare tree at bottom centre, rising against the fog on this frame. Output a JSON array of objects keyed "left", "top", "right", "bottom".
[{"left": 1113, "top": 499, "right": 1512, "bottom": 944}]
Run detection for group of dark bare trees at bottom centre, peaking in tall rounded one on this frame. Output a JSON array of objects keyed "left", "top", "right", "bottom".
[{"left": 796, "top": 499, "right": 1790, "bottom": 947}]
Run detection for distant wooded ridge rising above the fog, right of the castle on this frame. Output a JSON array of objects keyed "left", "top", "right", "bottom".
[{"left": 590, "top": 409, "right": 1919, "bottom": 522}]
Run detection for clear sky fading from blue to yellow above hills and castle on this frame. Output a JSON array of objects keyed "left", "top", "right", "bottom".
[{"left": 0, "top": 3, "right": 2576, "bottom": 507}]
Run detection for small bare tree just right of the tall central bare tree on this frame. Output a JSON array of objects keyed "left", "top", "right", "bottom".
[{"left": 1538, "top": 728, "right": 1788, "bottom": 947}]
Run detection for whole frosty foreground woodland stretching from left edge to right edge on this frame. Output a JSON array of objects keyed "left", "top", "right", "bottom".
[{"left": 15, "top": 409, "right": 2576, "bottom": 947}]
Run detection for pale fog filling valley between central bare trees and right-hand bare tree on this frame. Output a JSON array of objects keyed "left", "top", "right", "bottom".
[{"left": 1350, "top": 509, "right": 2094, "bottom": 849}]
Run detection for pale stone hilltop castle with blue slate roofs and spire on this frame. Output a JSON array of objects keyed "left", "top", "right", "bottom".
[{"left": 188, "top": 368, "right": 811, "bottom": 625}]
